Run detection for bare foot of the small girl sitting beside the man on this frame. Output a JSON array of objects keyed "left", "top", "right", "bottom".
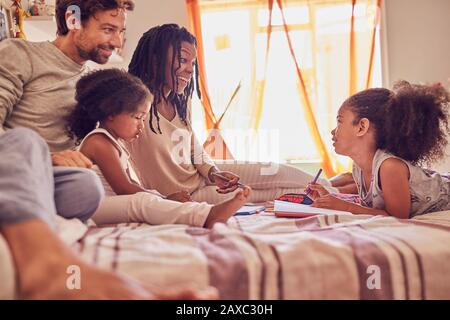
[{"left": 205, "top": 186, "right": 251, "bottom": 228}]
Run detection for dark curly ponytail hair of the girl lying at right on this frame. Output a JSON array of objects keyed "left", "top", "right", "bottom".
[{"left": 344, "top": 81, "right": 450, "bottom": 165}]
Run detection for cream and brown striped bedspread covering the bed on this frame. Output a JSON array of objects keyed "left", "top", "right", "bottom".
[{"left": 69, "top": 211, "right": 450, "bottom": 299}]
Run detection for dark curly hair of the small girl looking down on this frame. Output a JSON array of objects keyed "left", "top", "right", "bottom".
[{"left": 68, "top": 69, "right": 150, "bottom": 145}]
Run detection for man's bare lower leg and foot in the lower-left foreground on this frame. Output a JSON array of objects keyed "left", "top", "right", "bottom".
[{"left": 0, "top": 219, "right": 217, "bottom": 299}]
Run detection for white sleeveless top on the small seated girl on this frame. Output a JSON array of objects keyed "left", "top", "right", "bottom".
[{"left": 78, "top": 128, "right": 140, "bottom": 197}]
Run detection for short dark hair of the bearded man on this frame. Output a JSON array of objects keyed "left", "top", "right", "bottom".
[{"left": 55, "top": 0, "right": 134, "bottom": 36}]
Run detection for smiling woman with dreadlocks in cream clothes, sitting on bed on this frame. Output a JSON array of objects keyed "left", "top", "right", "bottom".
[{"left": 128, "top": 24, "right": 336, "bottom": 203}]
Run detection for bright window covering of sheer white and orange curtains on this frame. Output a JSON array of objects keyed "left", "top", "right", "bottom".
[{"left": 187, "top": 0, "right": 381, "bottom": 176}]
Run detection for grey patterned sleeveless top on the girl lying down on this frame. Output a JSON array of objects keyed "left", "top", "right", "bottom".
[{"left": 353, "top": 149, "right": 450, "bottom": 218}]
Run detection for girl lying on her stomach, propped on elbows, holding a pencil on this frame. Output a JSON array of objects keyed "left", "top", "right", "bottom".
[{"left": 309, "top": 82, "right": 450, "bottom": 219}]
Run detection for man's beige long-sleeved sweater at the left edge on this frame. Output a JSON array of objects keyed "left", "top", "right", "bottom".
[{"left": 0, "top": 39, "right": 85, "bottom": 152}]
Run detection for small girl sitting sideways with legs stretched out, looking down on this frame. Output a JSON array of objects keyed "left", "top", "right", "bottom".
[{"left": 69, "top": 69, "right": 250, "bottom": 227}]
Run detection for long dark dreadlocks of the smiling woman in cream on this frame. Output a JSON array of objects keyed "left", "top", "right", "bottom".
[{"left": 128, "top": 24, "right": 201, "bottom": 134}]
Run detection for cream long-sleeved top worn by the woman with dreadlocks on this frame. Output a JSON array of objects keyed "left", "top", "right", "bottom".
[{"left": 127, "top": 106, "right": 214, "bottom": 196}]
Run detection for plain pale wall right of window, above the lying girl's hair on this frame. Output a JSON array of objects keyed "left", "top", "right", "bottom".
[{"left": 382, "top": 0, "right": 450, "bottom": 171}]
